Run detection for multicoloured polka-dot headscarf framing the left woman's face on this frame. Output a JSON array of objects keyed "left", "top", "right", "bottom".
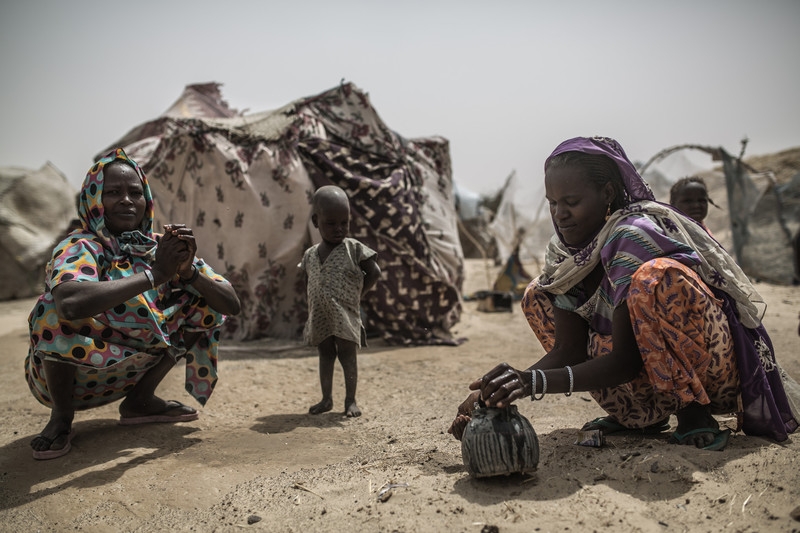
[{"left": 78, "top": 148, "right": 156, "bottom": 261}]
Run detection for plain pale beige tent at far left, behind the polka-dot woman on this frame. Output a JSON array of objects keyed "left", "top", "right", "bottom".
[{"left": 0, "top": 163, "right": 77, "bottom": 300}]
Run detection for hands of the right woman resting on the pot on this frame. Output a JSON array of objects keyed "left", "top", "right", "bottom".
[{"left": 447, "top": 363, "right": 531, "bottom": 440}]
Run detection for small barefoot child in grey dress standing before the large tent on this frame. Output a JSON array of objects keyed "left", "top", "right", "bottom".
[{"left": 299, "top": 185, "right": 381, "bottom": 417}]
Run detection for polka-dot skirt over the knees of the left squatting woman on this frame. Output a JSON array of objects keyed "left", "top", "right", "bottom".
[{"left": 25, "top": 285, "right": 221, "bottom": 410}]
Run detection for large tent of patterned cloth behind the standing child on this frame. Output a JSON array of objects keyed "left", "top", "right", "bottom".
[{"left": 98, "top": 83, "right": 464, "bottom": 344}]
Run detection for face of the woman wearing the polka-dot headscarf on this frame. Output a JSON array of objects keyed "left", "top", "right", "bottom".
[{"left": 102, "top": 163, "right": 147, "bottom": 235}]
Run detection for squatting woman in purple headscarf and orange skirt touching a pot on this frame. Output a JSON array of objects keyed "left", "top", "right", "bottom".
[{"left": 450, "top": 137, "right": 797, "bottom": 450}]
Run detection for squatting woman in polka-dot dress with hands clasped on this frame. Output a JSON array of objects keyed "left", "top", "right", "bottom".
[{"left": 25, "top": 149, "right": 240, "bottom": 459}]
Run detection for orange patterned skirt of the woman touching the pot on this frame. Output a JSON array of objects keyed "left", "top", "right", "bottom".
[{"left": 522, "top": 258, "right": 741, "bottom": 428}]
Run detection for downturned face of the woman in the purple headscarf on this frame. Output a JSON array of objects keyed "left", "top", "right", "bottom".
[{"left": 544, "top": 166, "right": 613, "bottom": 246}]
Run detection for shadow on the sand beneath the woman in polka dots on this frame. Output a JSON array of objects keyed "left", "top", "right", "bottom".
[{"left": 0, "top": 419, "right": 200, "bottom": 509}]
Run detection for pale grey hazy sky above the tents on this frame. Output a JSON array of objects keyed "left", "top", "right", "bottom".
[{"left": 0, "top": 0, "right": 800, "bottom": 192}]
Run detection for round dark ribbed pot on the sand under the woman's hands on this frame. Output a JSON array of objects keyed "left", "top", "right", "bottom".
[{"left": 461, "top": 404, "right": 539, "bottom": 477}]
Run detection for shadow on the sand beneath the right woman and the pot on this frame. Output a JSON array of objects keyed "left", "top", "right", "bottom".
[{"left": 451, "top": 429, "right": 771, "bottom": 505}]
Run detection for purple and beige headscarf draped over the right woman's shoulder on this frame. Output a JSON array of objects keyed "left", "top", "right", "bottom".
[{"left": 536, "top": 137, "right": 766, "bottom": 328}]
